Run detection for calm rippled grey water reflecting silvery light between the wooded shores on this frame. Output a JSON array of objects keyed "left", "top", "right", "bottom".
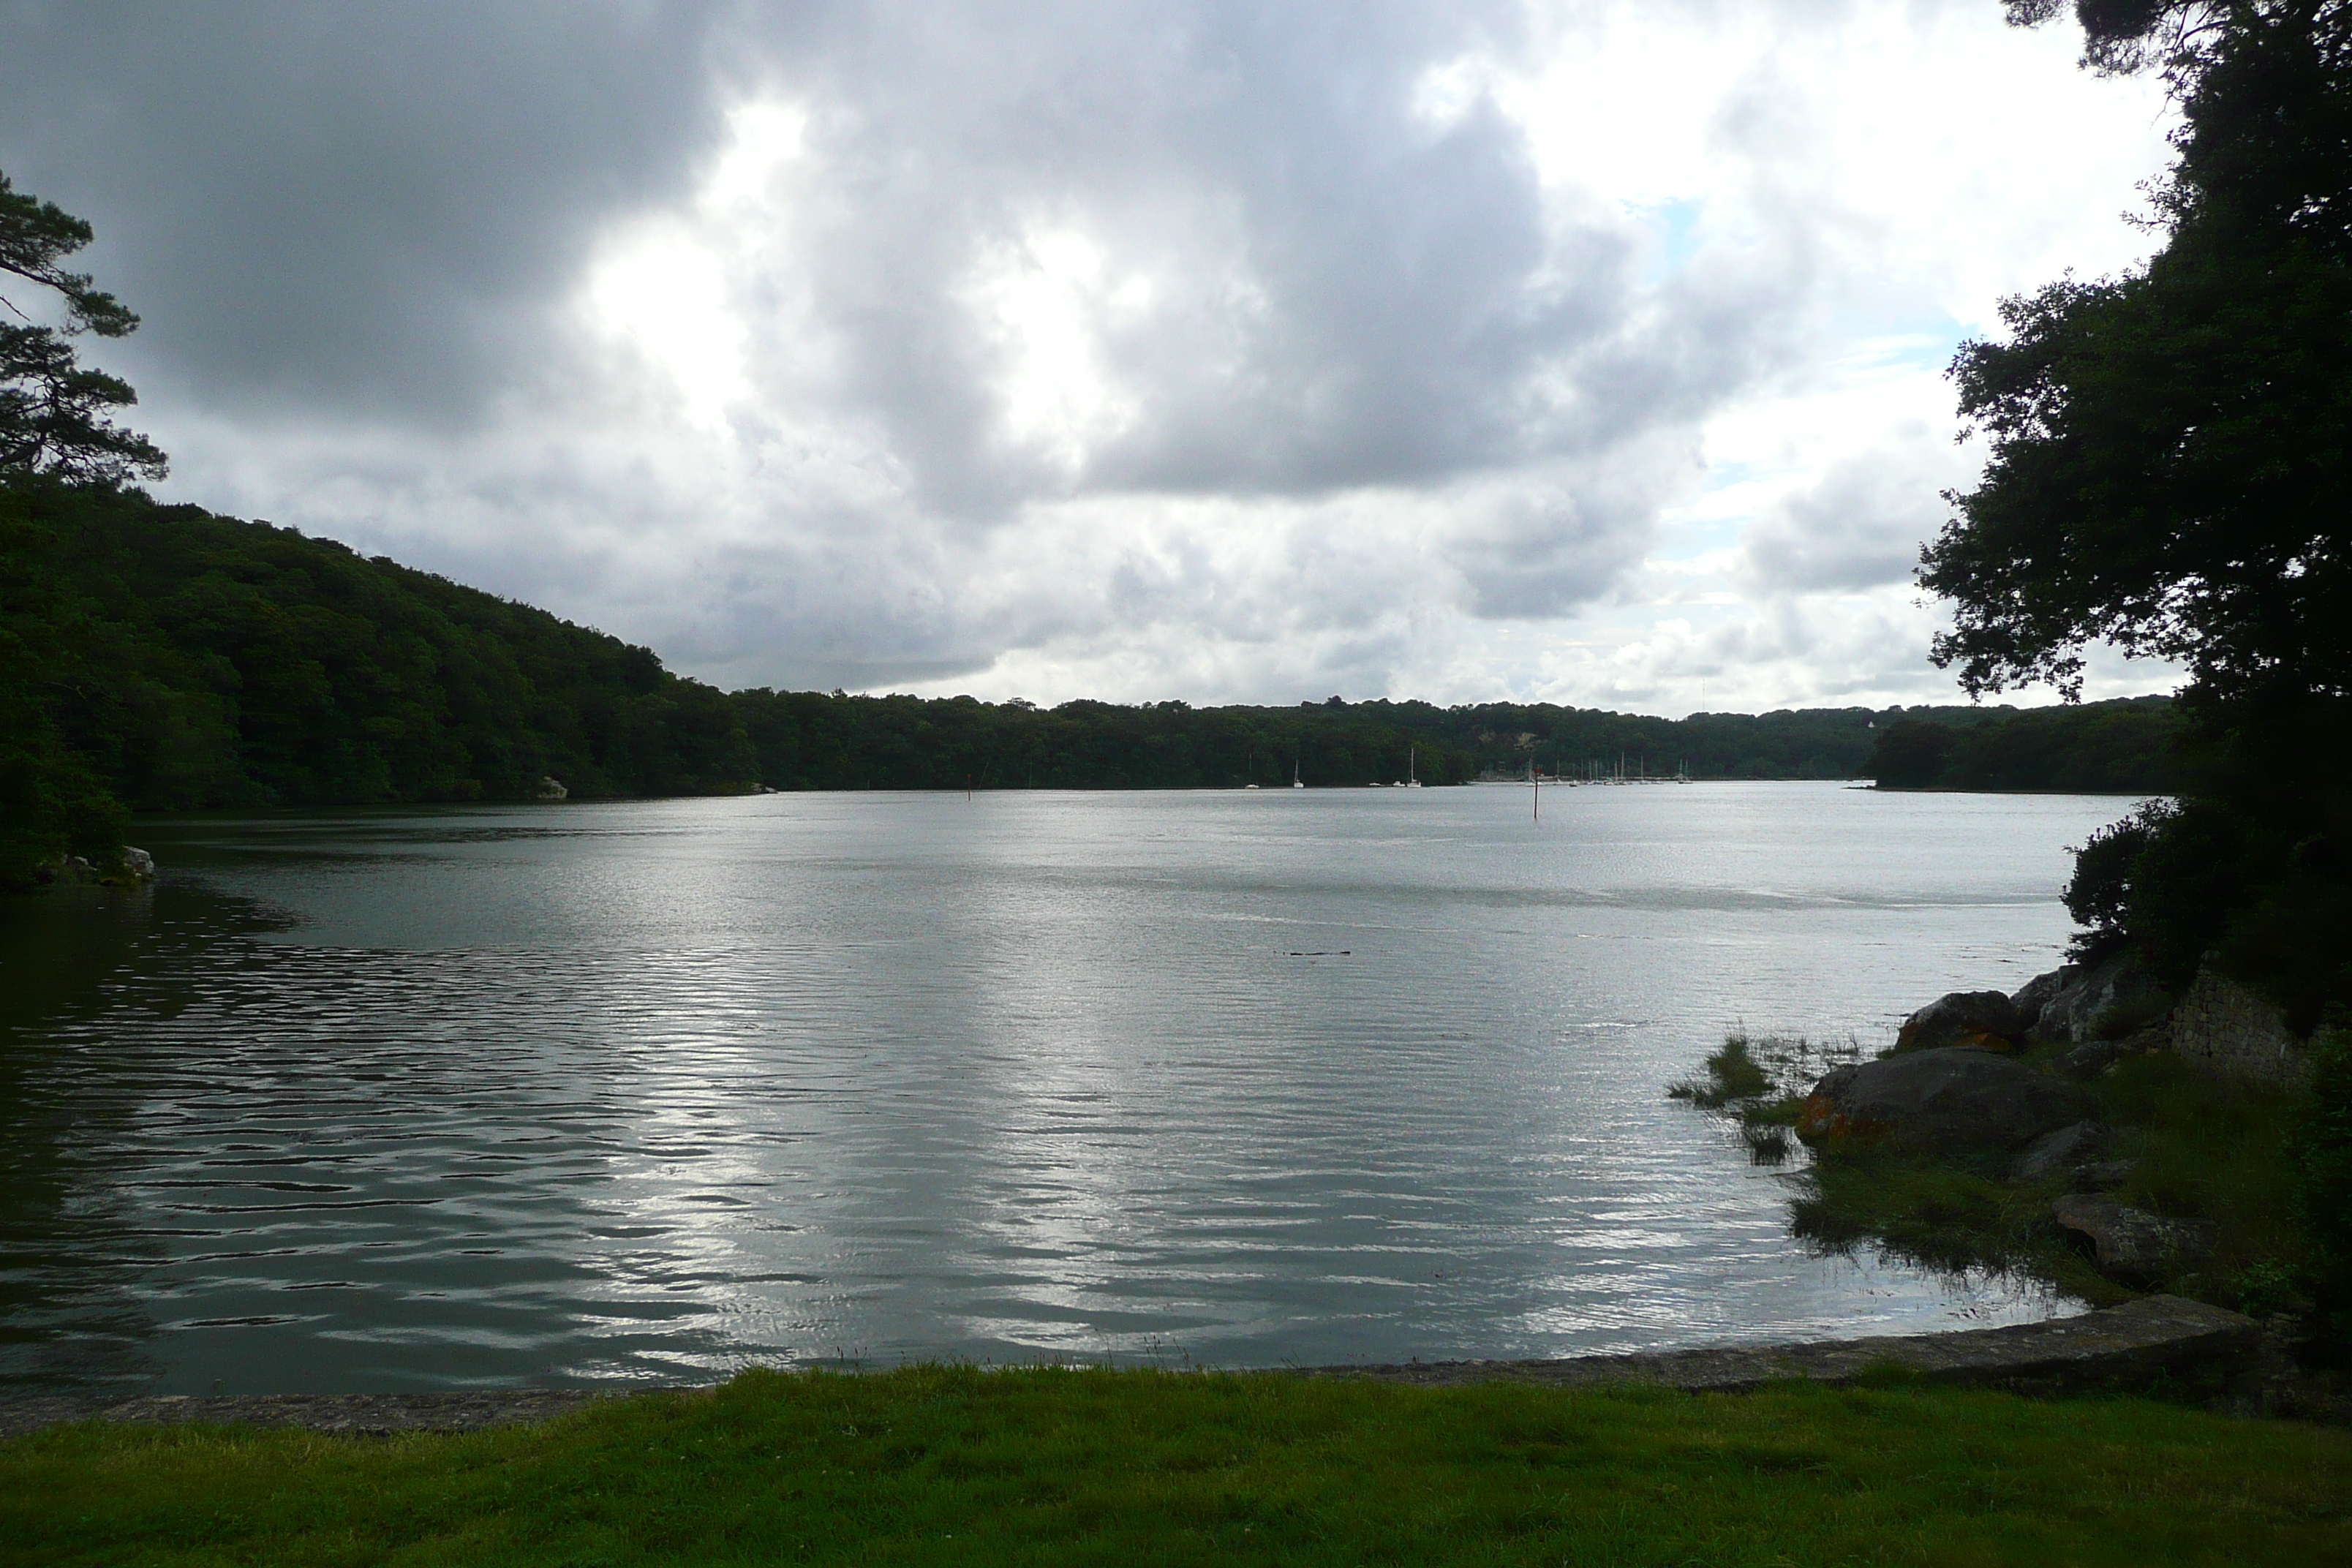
[{"left": 0, "top": 783, "right": 2128, "bottom": 1392}]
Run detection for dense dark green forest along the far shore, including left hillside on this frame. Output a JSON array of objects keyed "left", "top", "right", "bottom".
[{"left": 0, "top": 480, "right": 2171, "bottom": 881}]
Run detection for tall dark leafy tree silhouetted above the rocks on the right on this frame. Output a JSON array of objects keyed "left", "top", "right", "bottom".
[{"left": 1956, "top": 0, "right": 2352, "bottom": 1030}]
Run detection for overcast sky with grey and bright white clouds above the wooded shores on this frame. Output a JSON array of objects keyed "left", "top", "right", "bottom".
[{"left": 0, "top": 0, "right": 2171, "bottom": 715}]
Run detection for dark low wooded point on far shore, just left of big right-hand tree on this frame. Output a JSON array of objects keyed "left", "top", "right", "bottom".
[{"left": 1863, "top": 696, "right": 2185, "bottom": 794}]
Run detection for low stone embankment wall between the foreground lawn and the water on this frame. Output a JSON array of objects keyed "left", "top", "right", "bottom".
[{"left": 0, "top": 1295, "right": 2261, "bottom": 1436}]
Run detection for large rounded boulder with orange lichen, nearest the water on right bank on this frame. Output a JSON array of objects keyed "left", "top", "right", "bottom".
[{"left": 1797, "top": 1046, "right": 2093, "bottom": 1154}]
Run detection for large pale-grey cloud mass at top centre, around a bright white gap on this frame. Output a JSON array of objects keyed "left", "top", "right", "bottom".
[{"left": 720, "top": 2, "right": 1799, "bottom": 510}]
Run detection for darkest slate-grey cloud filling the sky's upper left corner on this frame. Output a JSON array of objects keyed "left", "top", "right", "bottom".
[{"left": 0, "top": 0, "right": 734, "bottom": 426}]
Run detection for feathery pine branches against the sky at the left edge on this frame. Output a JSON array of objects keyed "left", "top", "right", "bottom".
[{"left": 0, "top": 174, "right": 165, "bottom": 484}]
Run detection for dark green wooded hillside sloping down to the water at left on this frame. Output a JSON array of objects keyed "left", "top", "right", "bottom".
[{"left": 0, "top": 480, "right": 755, "bottom": 881}]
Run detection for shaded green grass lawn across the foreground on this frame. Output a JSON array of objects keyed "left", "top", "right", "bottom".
[{"left": 0, "top": 1368, "right": 2352, "bottom": 1568}]
